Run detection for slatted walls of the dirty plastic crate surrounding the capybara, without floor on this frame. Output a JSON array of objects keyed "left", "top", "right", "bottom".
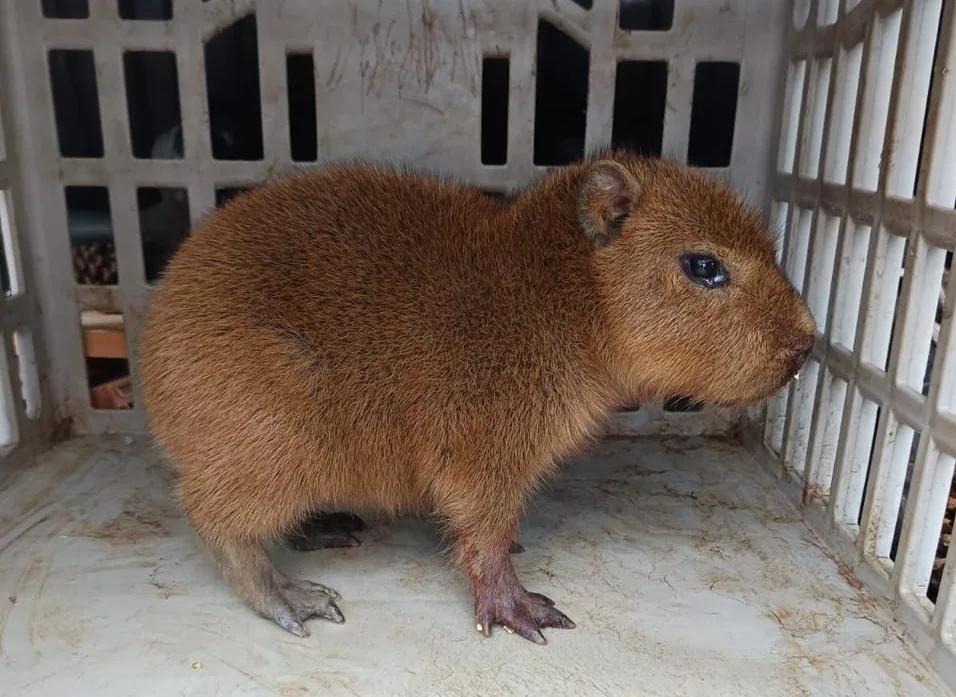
[{"left": 0, "top": 0, "right": 956, "bottom": 687}]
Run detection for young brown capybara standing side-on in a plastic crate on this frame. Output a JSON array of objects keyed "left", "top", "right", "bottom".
[{"left": 139, "top": 151, "right": 816, "bottom": 644}]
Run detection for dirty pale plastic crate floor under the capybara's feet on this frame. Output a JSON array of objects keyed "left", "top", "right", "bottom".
[{"left": 0, "top": 439, "right": 949, "bottom": 697}]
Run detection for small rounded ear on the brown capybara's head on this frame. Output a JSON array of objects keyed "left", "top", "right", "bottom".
[{"left": 578, "top": 160, "right": 640, "bottom": 249}]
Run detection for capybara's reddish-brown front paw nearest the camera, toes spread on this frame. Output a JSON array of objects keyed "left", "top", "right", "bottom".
[{"left": 475, "top": 586, "right": 574, "bottom": 644}]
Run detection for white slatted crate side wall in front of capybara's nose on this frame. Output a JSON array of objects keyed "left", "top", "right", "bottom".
[{"left": 761, "top": 0, "right": 956, "bottom": 685}]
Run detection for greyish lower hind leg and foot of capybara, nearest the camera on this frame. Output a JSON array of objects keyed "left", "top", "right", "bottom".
[{"left": 210, "top": 541, "right": 345, "bottom": 637}]
